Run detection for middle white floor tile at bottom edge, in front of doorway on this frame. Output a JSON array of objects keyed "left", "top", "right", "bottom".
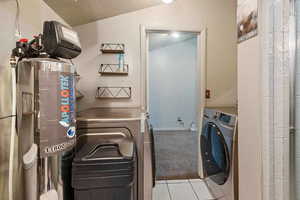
[{"left": 168, "top": 183, "right": 197, "bottom": 200}]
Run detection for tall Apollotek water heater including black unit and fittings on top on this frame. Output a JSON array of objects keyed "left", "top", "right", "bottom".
[{"left": 5, "top": 21, "right": 81, "bottom": 200}]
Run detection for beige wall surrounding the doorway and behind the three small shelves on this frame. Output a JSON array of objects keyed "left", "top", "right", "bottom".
[{"left": 75, "top": 0, "right": 237, "bottom": 109}]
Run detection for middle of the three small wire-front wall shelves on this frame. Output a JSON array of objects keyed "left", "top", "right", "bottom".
[{"left": 99, "top": 64, "right": 129, "bottom": 76}]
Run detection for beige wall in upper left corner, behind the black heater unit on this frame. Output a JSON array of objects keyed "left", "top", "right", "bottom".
[{"left": 0, "top": 0, "right": 66, "bottom": 67}]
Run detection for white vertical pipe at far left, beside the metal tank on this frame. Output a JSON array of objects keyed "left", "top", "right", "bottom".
[{"left": 8, "top": 67, "right": 16, "bottom": 200}]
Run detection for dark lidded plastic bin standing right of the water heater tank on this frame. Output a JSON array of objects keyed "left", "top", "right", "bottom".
[{"left": 72, "top": 140, "right": 136, "bottom": 200}]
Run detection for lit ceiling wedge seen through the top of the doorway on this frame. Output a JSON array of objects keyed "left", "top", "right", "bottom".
[{"left": 149, "top": 32, "right": 197, "bottom": 51}]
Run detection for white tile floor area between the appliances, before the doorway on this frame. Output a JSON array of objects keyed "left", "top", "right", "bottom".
[{"left": 153, "top": 179, "right": 215, "bottom": 200}]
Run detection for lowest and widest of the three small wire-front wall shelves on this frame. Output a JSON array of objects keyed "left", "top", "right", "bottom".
[{"left": 96, "top": 87, "right": 131, "bottom": 99}]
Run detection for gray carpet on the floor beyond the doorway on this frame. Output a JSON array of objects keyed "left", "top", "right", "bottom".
[{"left": 154, "top": 131, "right": 198, "bottom": 180}]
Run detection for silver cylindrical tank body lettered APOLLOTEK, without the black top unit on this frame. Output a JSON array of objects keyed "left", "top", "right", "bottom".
[{"left": 17, "top": 58, "right": 76, "bottom": 200}]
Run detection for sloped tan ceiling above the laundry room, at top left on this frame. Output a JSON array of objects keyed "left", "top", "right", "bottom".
[{"left": 44, "top": 0, "right": 162, "bottom": 26}]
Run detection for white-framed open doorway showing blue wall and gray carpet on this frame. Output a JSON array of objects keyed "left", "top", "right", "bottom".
[{"left": 141, "top": 28, "right": 206, "bottom": 180}]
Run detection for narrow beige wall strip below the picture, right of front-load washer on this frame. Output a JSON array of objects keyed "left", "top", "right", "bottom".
[{"left": 238, "top": 0, "right": 262, "bottom": 200}]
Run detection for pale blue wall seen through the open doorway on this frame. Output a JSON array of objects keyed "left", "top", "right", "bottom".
[{"left": 149, "top": 37, "right": 201, "bottom": 130}]
